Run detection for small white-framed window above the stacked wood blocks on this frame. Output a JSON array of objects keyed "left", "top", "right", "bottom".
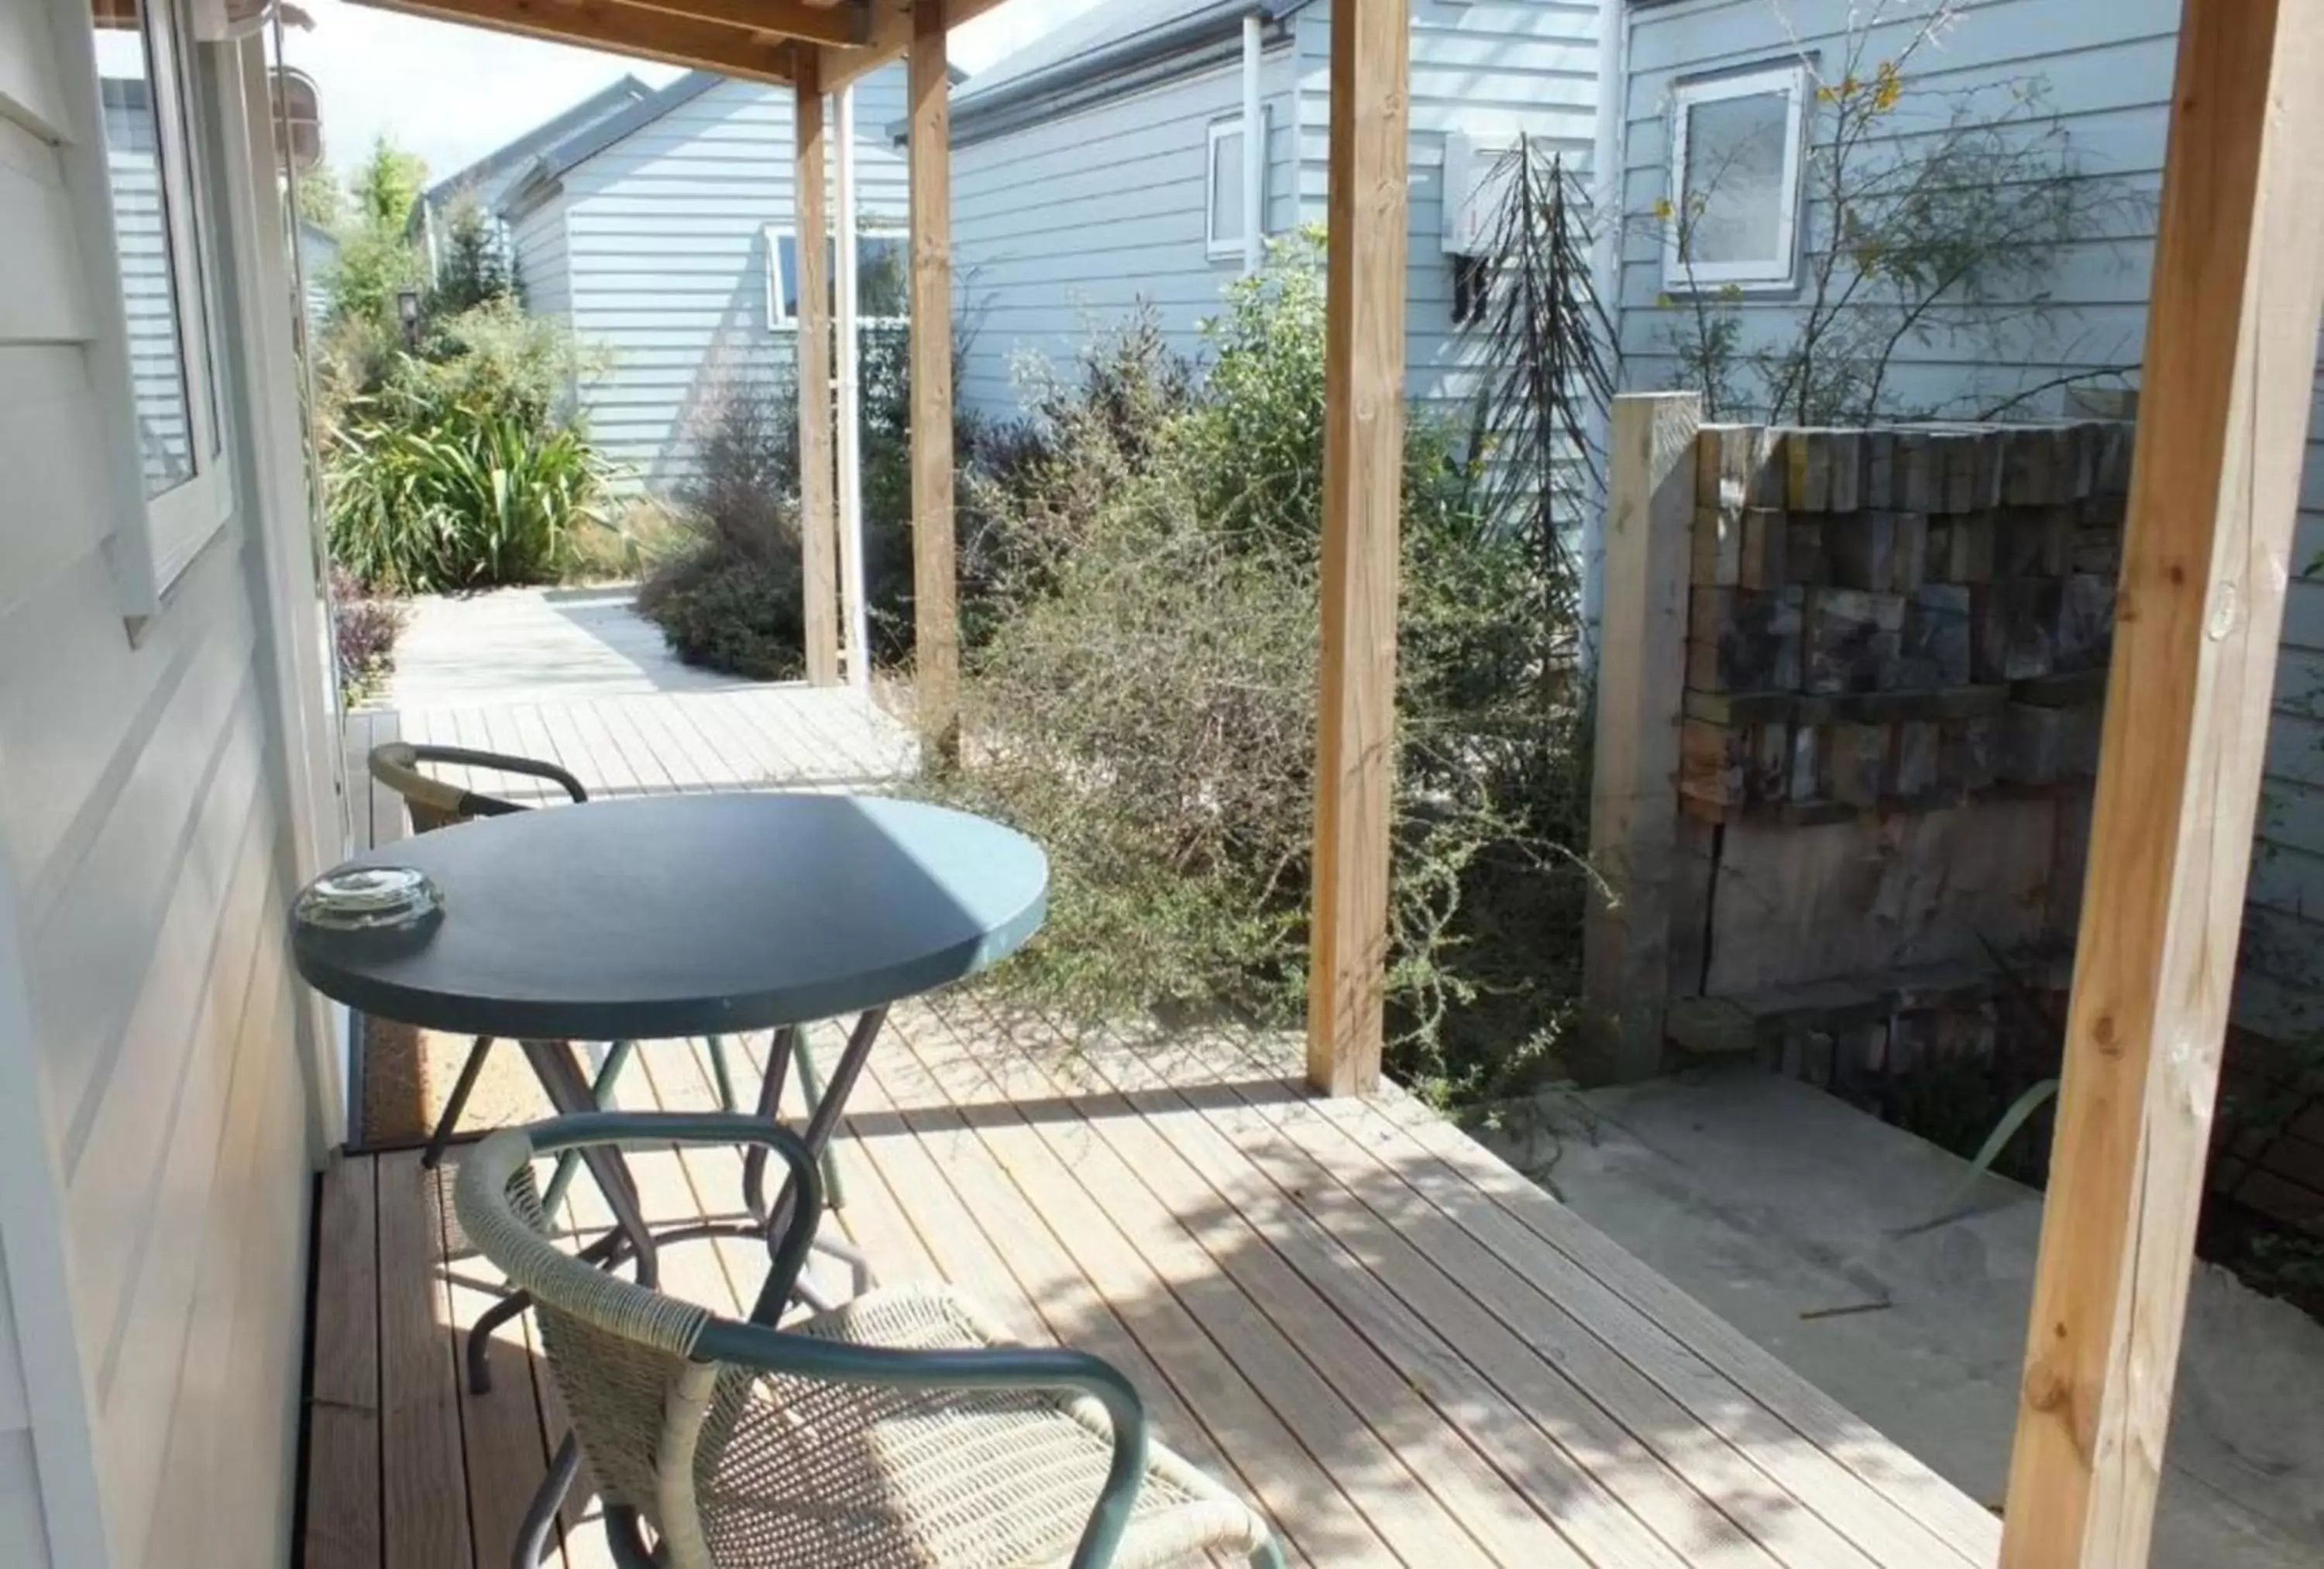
[{"left": 1662, "top": 65, "right": 1808, "bottom": 290}]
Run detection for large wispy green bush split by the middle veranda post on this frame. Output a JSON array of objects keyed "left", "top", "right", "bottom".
[{"left": 939, "top": 239, "right": 1587, "bottom": 1097}]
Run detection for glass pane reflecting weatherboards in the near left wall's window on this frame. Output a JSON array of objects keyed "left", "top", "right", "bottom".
[{"left": 93, "top": 0, "right": 193, "bottom": 497}]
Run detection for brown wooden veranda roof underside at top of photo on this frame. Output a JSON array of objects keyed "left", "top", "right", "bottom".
[{"left": 342, "top": 0, "right": 999, "bottom": 91}]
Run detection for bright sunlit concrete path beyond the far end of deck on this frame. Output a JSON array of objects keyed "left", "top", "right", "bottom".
[{"left": 388, "top": 583, "right": 739, "bottom": 709}]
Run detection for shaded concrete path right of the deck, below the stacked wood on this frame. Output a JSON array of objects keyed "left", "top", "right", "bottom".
[{"left": 1499, "top": 1069, "right": 2324, "bottom": 1569}]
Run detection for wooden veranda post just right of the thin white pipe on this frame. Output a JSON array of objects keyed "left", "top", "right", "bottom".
[{"left": 906, "top": 0, "right": 960, "bottom": 757}]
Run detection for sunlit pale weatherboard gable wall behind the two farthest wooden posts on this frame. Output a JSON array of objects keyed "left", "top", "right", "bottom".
[{"left": 511, "top": 65, "right": 904, "bottom": 490}]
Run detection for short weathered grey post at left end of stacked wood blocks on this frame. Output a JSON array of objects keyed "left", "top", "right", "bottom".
[{"left": 1573, "top": 393, "right": 1703, "bottom": 1083}]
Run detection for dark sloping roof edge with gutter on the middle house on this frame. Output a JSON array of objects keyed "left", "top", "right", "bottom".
[{"left": 939, "top": 0, "right": 1311, "bottom": 146}]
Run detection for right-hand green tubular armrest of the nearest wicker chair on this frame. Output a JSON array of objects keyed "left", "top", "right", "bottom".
[{"left": 695, "top": 1318, "right": 1146, "bottom": 1569}]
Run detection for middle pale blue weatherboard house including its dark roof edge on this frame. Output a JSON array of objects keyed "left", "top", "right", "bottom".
[{"left": 934, "top": 0, "right": 1606, "bottom": 411}]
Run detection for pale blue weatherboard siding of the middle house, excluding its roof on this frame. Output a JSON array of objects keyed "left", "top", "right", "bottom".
[{"left": 953, "top": 0, "right": 1599, "bottom": 414}]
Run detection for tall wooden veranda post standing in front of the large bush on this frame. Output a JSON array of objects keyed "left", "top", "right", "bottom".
[{"left": 1308, "top": 0, "right": 1408, "bottom": 1095}]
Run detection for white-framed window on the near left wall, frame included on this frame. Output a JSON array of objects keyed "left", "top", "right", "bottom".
[{"left": 91, "top": 0, "right": 232, "bottom": 597}]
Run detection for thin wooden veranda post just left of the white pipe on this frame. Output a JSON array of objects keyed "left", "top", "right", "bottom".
[{"left": 792, "top": 63, "right": 839, "bottom": 685}]
